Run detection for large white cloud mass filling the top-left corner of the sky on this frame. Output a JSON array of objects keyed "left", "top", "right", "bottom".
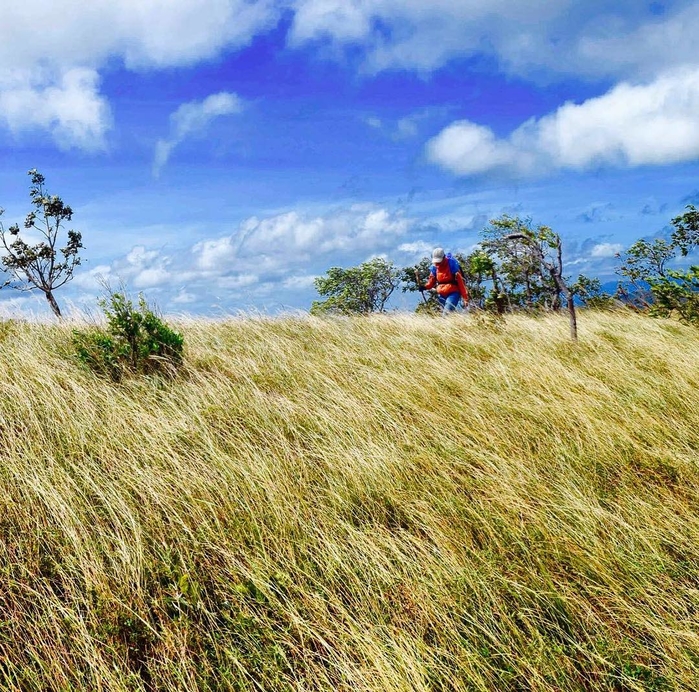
[{"left": 0, "top": 0, "right": 280, "bottom": 151}]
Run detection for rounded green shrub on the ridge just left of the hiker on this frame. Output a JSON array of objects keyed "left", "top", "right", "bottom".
[{"left": 311, "top": 257, "right": 400, "bottom": 315}]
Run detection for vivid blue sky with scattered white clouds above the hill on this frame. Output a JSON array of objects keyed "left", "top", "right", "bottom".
[{"left": 0, "top": 0, "right": 699, "bottom": 317}]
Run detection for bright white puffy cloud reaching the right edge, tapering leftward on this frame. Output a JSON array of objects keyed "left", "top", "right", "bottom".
[{"left": 427, "top": 68, "right": 699, "bottom": 175}]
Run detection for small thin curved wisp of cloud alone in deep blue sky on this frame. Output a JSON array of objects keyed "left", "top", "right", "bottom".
[{"left": 153, "top": 91, "right": 242, "bottom": 177}]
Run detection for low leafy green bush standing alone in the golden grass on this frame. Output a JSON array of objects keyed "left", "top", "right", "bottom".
[{"left": 73, "top": 293, "right": 184, "bottom": 381}]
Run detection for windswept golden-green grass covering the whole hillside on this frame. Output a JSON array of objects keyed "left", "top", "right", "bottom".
[{"left": 0, "top": 314, "right": 699, "bottom": 692}]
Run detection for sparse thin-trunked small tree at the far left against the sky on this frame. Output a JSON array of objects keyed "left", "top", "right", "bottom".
[{"left": 0, "top": 170, "right": 83, "bottom": 317}]
